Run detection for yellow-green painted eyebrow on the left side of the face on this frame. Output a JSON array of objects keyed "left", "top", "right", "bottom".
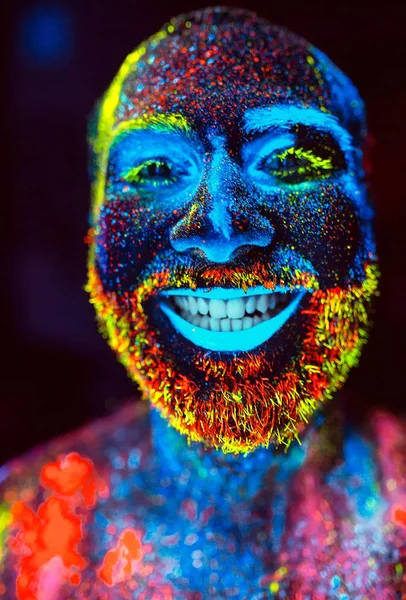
[{"left": 111, "top": 113, "right": 191, "bottom": 144}]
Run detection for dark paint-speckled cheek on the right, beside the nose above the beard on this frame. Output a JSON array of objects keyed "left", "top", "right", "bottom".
[{"left": 272, "top": 188, "right": 361, "bottom": 286}]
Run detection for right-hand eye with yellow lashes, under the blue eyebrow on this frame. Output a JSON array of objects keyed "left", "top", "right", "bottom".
[{"left": 259, "top": 146, "right": 336, "bottom": 184}]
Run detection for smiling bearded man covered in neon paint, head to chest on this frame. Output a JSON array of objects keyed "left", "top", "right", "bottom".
[{"left": 0, "top": 8, "right": 406, "bottom": 600}]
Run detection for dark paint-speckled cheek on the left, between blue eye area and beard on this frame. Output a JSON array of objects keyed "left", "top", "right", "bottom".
[{"left": 95, "top": 198, "right": 174, "bottom": 291}]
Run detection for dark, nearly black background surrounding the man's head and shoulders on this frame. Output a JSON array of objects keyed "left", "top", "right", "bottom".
[{"left": 0, "top": 0, "right": 406, "bottom": 462}]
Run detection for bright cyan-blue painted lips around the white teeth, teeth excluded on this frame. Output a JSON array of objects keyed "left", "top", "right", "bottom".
[{"left": 159, "top": 286, "right": 310, "bottom": 352}]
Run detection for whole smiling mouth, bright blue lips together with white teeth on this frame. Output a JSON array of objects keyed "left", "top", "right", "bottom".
[{"left": 160, "top": 286, "right": 309, "bottom": 352}]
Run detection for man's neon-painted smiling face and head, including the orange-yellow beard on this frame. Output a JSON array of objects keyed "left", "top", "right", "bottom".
[{"left": 88, "top": 9, "right": 376, "bottom": 452}]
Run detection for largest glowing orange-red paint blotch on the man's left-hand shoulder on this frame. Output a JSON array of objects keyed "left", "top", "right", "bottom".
[{"left": 10, "top": 453, "right": 99, "bottom": 600}]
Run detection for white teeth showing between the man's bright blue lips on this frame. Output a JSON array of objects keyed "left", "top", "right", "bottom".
[{"left": 173, "top": 293, "right": 293, "bottom": 332}]
